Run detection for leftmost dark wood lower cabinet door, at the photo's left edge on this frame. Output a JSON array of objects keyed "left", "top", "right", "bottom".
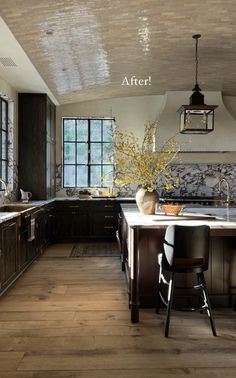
[{"left": 1, "top": 222, "right": 17, "bottom": 285}]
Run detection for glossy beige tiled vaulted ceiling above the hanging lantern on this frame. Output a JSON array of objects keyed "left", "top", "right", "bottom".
[{"left": 0, "top": 0, "right": 236, "bottom": 104}]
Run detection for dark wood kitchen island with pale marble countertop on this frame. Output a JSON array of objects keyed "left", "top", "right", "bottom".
[{"left": 121, "top": 205, "right": 236, "bottom": 323}]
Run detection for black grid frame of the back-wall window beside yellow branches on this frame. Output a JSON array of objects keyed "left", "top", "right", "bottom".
[{"left": 62, "top": 117, "right": 115, "bottom": 189}]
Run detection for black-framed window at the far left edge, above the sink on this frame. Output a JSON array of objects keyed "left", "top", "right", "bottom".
[{"left": 0, "top": 96, "right": 9, "bottom": 191}]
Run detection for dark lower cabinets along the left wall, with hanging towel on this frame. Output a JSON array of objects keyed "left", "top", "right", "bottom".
[{"left": 0, "top": 202, "right": 53, "bottom": 293}]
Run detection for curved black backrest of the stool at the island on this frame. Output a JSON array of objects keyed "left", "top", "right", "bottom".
[{"left": 163, "top": 225, "right": 210, "bottom": 270}]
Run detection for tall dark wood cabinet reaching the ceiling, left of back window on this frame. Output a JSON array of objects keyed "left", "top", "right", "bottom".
[{"left": 18, "top": 93, "right": 56, "bottom": 200}]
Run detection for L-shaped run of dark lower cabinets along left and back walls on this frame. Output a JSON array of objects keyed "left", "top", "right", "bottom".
[{"left": 0, "top": 199, "right": 133, "bottom": 294}]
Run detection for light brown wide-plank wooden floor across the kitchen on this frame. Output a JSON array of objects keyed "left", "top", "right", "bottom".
[{"left": 0, "top": 244, "right": 236, "bottom": 378}]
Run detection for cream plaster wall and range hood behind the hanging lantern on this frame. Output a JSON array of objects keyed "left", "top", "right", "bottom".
[{"left": 57, "top": 92, "right": 236, "bottom": 163}]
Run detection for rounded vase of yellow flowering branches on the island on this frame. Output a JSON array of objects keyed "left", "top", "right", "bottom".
[{"left": 113, "top": 122, "right": 180, "bottom": 214}]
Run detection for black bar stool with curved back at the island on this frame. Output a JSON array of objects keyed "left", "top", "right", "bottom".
[{"left": 156, "top": 225, "right": 216, "bottom": 337}]
